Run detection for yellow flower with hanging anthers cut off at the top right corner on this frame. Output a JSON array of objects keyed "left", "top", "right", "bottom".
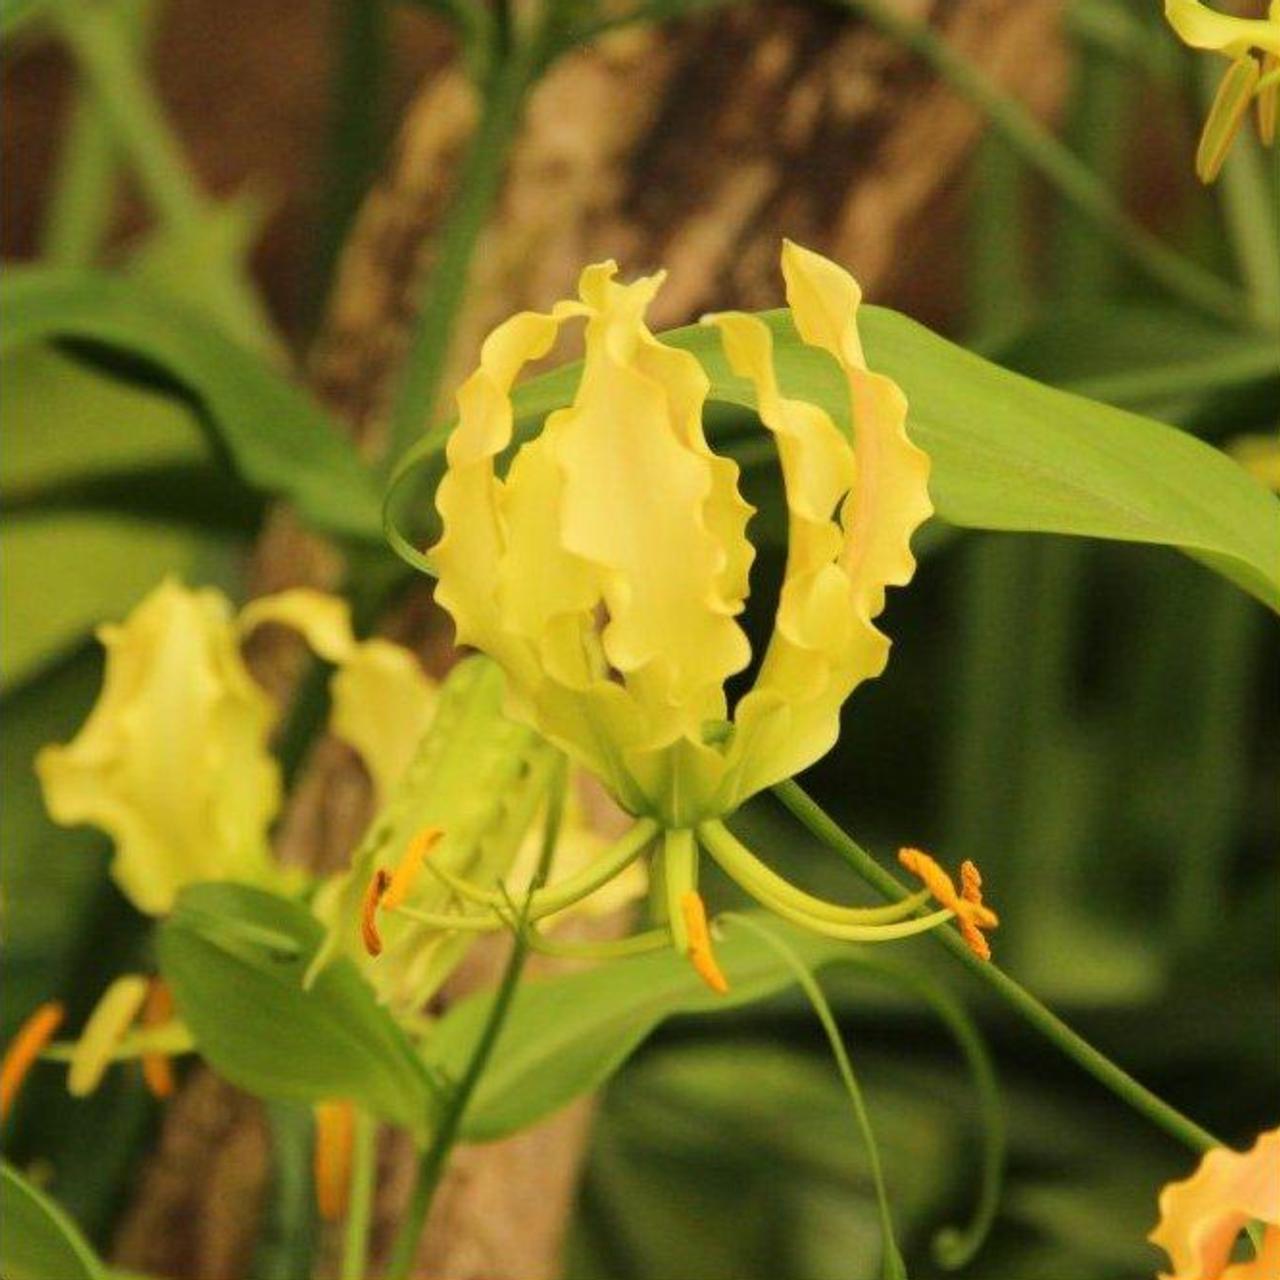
[{"left": 1165, "top": 0, "right": 1280, "bottom": 182}]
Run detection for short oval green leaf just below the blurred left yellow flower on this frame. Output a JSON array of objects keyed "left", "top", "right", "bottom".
[{"left": 157, "top": 883, "right": 436, "bottom": 1135}]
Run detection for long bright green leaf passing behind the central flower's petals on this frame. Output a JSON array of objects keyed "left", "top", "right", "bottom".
[{"left": 385, "top": 307, "right": 1280, "bottom": 609}]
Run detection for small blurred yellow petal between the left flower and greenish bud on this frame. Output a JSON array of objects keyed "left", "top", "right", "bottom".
[{"left": 329, "top": 640, "right": 438, "bottom": 805}]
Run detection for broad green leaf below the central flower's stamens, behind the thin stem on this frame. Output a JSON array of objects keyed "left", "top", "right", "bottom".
[{"left": 428, "top": 925, "right": 856, "bottom": 1142}]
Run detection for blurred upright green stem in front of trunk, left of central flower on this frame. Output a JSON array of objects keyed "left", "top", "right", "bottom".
[{"left": 383, "top": 41, "right": 536, "bottom": 472}]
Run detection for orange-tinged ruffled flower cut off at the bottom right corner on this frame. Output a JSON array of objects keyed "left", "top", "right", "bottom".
[{"left": 1149, "top": 1129, "right": 1280, "bottom": 1280}]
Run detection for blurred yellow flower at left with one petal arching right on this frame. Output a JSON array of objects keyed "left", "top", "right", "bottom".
[{"left": 36, "top": 580, "right": 351, "bottom": 915}]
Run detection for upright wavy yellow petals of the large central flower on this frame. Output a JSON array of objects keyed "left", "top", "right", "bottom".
[{"left": 431, "top": 244, "right": 932, "bottom": 828}]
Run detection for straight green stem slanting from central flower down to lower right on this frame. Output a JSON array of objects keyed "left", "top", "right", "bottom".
[{"left": 773, "top": 780, "right": 1222, "bottom": 1151}]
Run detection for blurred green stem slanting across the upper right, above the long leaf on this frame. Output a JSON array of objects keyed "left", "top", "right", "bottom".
[{"left": 836, "top": 0, "right": 1248, "bottom": 324}]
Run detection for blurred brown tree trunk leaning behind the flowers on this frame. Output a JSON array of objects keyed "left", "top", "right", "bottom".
[{"left": 118, "top": 0, "right": 1061, "bottom": 1280}]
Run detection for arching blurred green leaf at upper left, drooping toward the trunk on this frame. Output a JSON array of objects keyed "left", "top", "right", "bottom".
[{"left": 0, "top": 268, "right": 379, "bottom": 540}]
